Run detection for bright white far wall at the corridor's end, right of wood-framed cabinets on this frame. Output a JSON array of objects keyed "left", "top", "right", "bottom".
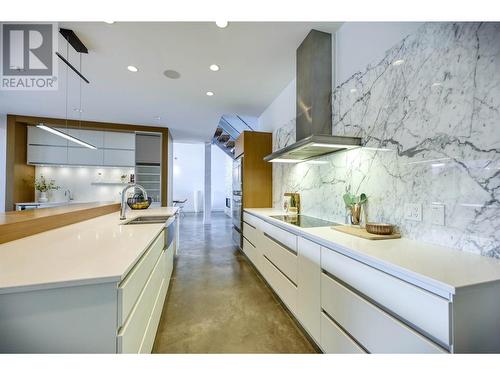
[{"left": 173, "top": 142, "right": 205, "bottom": 212}]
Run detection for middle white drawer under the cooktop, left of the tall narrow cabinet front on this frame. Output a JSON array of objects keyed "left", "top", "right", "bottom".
[{"left": 260, "top": 234, "right": 298, "bottom": 285}]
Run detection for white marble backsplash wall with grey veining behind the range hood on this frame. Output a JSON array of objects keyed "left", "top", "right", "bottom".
[{"left": 273, "top": 23, "right": 500, "bottom": 258}]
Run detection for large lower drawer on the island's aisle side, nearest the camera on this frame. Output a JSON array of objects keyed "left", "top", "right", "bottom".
[{"left": 117, "top": 252, "right": 166, "bottom": 353}]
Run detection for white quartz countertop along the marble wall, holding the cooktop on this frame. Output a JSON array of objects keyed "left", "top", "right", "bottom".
[{"left": 245, "top": 208, "right": 500, "bottom": 294}]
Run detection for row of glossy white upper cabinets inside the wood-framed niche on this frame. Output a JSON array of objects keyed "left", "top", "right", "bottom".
[{"left": 27, "top": 126, "right": 135, "bottom": 167}]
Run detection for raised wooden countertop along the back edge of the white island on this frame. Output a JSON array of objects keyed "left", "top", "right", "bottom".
[{"left": 0, "top": 202, "right": 120, "bottom": 243}]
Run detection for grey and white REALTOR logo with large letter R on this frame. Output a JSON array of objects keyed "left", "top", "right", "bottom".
[{"left": 0, "top": 23, "right": 58, "bottom": 90}]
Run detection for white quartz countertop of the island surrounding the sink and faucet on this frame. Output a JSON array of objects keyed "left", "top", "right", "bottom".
[{"left": 0, "top": 207, "right": 178, "bottom": 294}]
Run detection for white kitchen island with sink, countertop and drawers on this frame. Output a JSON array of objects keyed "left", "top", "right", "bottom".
[{"left": 0, "top": 207, "right": 177, "bottom": 353}]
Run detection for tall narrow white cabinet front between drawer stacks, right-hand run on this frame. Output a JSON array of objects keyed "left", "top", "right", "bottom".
[{"left": 297, "top": 237, "right": 321, "bottom": 343}]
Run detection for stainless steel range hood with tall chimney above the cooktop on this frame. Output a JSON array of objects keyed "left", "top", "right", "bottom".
[{"left": 264, "top": 30, "right": 361, "bottom": 163}]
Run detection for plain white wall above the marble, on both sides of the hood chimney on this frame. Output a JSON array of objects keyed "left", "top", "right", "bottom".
[{"left": 259, "top": 22, "right": 422, "bottom": 131}]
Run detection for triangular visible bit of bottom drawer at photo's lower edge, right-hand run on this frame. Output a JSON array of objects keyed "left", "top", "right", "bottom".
[{"left": 321, "top": 312, "right": 366, "bottom": 354}]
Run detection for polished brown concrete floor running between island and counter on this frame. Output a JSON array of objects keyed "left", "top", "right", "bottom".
[{"left": 153, "top": 213, "right": 315, "bottom": 353}]
